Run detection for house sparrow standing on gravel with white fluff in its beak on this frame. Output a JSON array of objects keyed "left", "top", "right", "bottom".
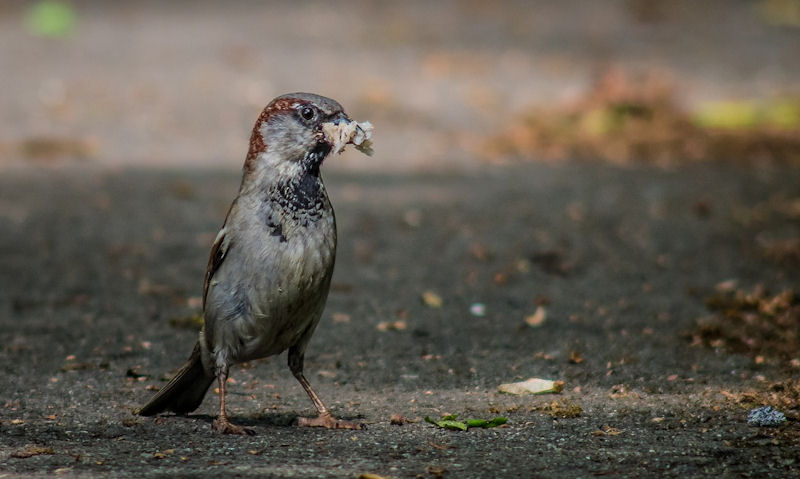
[{"left": 138, "top": 93, "right": 372, "bottom": 434}]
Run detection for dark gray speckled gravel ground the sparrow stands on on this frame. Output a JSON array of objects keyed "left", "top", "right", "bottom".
[{"left": 0, "top": 164, "right": 798, "bottom": 478}]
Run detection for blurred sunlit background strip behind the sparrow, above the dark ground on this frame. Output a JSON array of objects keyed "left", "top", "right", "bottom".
[{"left": 0, "top": 0, "right": 800, "bottom": 171}]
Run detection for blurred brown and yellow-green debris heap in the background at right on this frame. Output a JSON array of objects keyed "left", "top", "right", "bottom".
[{"left": 483, "top": 68, "right": 800, "bottom": 166}]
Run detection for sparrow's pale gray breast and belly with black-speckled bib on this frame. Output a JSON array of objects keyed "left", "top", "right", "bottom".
[{"left": 206, "top": 176, "right": 336, "bottom": 361}]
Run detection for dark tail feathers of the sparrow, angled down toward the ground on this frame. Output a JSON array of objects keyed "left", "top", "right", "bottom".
[{"left": 137, "top": 343, "right": 214, "bottom": 416}]
